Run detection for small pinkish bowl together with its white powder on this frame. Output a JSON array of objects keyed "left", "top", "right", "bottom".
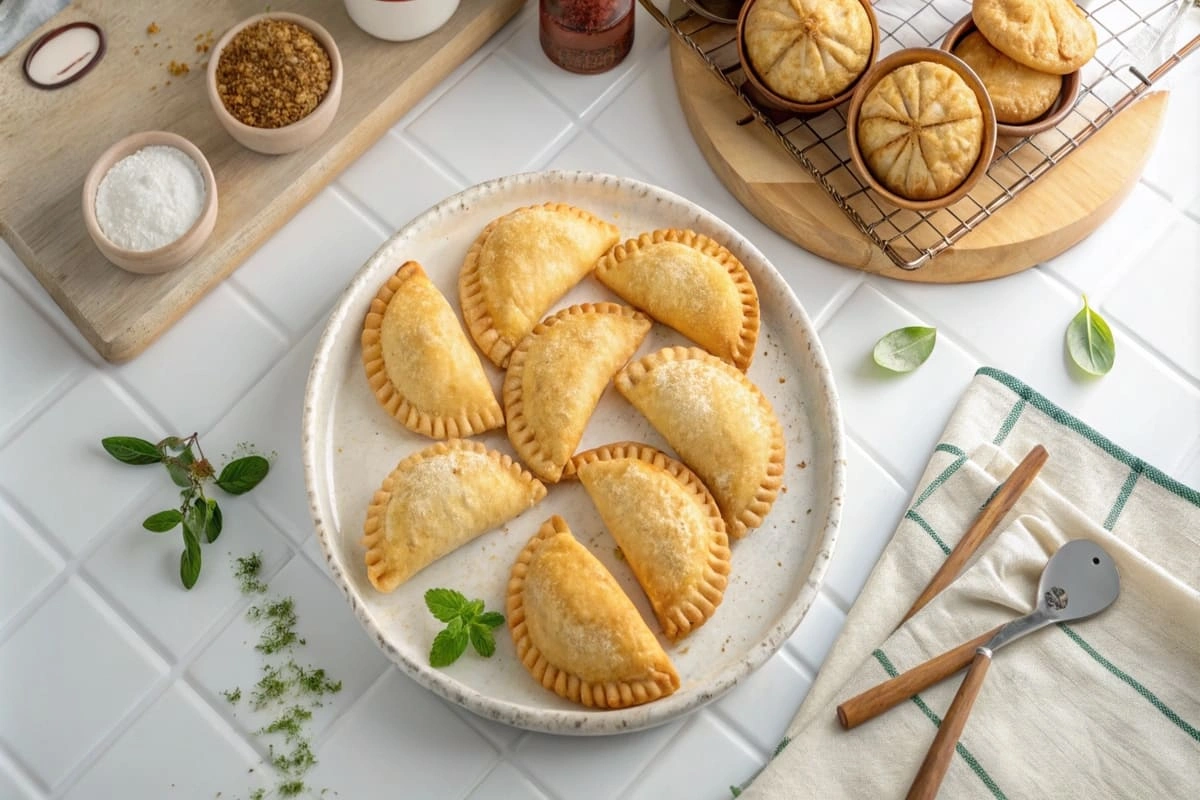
[{"left": 83, "top": 131, "right": 217, "bottom": 275}]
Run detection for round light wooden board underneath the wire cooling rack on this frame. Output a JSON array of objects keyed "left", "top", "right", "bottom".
[{"left": 671, "top": 36, "right": 1166, "bottom": 283}]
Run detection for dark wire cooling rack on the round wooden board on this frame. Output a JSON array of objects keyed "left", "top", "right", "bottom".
[{"left": 641, "top": 0, "right": 1200, "bottom": 270}]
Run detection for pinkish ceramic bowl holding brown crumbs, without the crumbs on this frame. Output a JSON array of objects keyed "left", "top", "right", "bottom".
[{"left": 205, "top": 11, "right": 342, "bottom": 155}]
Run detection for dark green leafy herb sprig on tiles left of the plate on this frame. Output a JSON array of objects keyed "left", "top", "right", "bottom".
[{"left": 100, "top": 433, "right": 270, "bottom": 589}]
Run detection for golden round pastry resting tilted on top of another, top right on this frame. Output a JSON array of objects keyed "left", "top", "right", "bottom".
[{"left": 971, "top": 0, "right": 1096, "bottom": 76}]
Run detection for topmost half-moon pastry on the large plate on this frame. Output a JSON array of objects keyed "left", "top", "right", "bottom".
[{"left": 458, "top": 203, "right": 619, "bottom": 368}]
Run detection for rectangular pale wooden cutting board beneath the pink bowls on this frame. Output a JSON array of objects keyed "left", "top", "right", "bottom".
[{"left": 0, "top": 0, "right": 523, "bottom": 361}]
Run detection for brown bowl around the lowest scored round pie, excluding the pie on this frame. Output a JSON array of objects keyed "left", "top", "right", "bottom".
[{"left": 846, "top": 47, "right": 996, "bottom": 211}]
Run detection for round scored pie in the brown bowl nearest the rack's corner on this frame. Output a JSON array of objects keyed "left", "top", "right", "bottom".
[{"left": 858, "top": 61, "right": 984, "bottom": 200}]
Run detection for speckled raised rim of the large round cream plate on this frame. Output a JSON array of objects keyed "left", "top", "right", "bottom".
[{"left": 301, "top": 169, "right": 846, "bottom": 735}]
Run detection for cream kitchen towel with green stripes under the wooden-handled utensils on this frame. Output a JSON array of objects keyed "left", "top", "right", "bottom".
[{"left": 740, "top": 368, "right": 1200, "bottom": 800}]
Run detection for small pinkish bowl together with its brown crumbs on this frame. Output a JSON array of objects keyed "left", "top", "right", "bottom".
[{"left": 206, "top": 12, "right": 342, "bottom": 155}]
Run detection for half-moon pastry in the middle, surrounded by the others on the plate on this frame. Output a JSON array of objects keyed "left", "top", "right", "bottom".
[{"left": 502, "top": 302, "right": 650, "bottom": 482}]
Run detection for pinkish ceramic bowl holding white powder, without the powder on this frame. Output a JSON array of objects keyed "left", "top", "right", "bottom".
[{"left": 83, "top": 131, "right": 217, "bottom": 275}]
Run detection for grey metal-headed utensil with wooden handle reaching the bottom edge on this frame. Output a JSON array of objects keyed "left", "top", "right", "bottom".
[{"left": 908, "top": 539, "right": 1121, "bottom": 800}]
